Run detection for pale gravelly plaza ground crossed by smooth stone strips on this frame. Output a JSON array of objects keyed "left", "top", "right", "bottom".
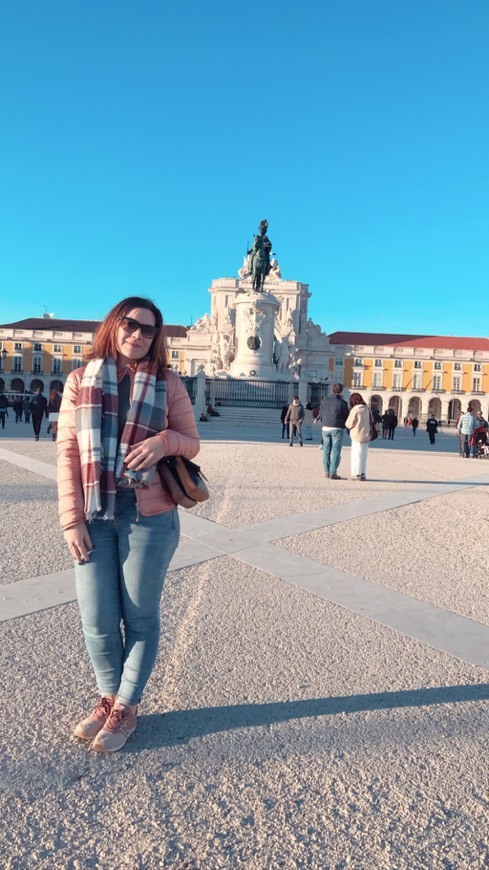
[{"left": 0, "top": 419, "right": 489, "bottom": 870}]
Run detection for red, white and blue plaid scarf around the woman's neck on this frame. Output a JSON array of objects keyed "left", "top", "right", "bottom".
[{"left": 75, "top": 357, "right": 167, "bottom": 521}]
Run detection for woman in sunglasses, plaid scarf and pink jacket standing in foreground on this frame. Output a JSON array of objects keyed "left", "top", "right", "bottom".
[{"left": 58, "top": 296, "right": 199, "bottom": 752}]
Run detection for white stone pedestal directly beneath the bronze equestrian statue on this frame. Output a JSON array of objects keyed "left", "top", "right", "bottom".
[{"left": 231, "top": 292, "right": 280, "bottom": 380}]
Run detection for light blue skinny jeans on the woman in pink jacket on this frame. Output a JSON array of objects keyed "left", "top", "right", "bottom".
[{"left": 75, "top": 490, "right": 180, "bottom": 705}]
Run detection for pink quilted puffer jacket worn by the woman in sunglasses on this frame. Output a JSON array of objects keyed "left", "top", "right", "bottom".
[{"left": 57, "top": 367, "right": 200, "bottom": 531}]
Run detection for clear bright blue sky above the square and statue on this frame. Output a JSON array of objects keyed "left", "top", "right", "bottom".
[{"left": 0, "top": 0, "right": 489, "bottom": 335}]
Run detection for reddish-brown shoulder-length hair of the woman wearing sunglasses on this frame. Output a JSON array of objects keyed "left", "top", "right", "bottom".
[{"left": 86, "top": 296, "right": 168, "bottom": 369}]
